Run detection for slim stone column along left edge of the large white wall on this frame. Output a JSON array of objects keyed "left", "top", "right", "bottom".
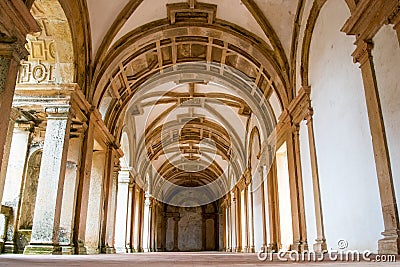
[{"left": 306, "top": 109, "right": 327, "bottom": 253}]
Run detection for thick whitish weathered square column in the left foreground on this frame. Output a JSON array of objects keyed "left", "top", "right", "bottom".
[{"left": 24, "top": 106, "right": 71, "bottom": 254}]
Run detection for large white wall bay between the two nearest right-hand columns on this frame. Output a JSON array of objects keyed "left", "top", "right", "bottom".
[{"left": 302, "top": 1, "right": 384, "bottom": 252}]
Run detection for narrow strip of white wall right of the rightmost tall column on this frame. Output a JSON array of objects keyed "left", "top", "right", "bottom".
[{"left": 372, "top": 25, "right": 400, "bottom": 209}]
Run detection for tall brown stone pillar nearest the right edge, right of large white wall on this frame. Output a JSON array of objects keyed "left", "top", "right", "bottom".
[{"left": 353, "top": 41, "right": 400, "bottom": 254}]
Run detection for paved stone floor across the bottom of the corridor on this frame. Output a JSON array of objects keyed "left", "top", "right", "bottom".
[{"left": 0, "top": 252, "right": 400, "bottom": 267}]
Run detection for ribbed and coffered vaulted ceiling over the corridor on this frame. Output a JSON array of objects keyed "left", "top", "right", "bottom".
[{"left": 22, "top": 0, "right": 299, "bottom": 204}]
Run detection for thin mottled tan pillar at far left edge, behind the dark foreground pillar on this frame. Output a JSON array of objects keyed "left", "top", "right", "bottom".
[{"left": 0, "top": 108, "right": 20, "bottom": 205}]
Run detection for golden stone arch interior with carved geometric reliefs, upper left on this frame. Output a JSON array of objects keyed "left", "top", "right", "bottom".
[{"left": 17, "top": 0, "right": 75, "bottom": 85}]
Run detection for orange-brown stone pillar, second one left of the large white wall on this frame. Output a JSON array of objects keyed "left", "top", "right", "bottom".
[{"left": 286, "top": 125, "right": 308, "bottom": 251}]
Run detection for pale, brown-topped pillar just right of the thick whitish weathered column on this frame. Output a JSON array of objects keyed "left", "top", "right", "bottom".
[{"left": 58, "top": 130, "right": 83, "bottom": 255}]
